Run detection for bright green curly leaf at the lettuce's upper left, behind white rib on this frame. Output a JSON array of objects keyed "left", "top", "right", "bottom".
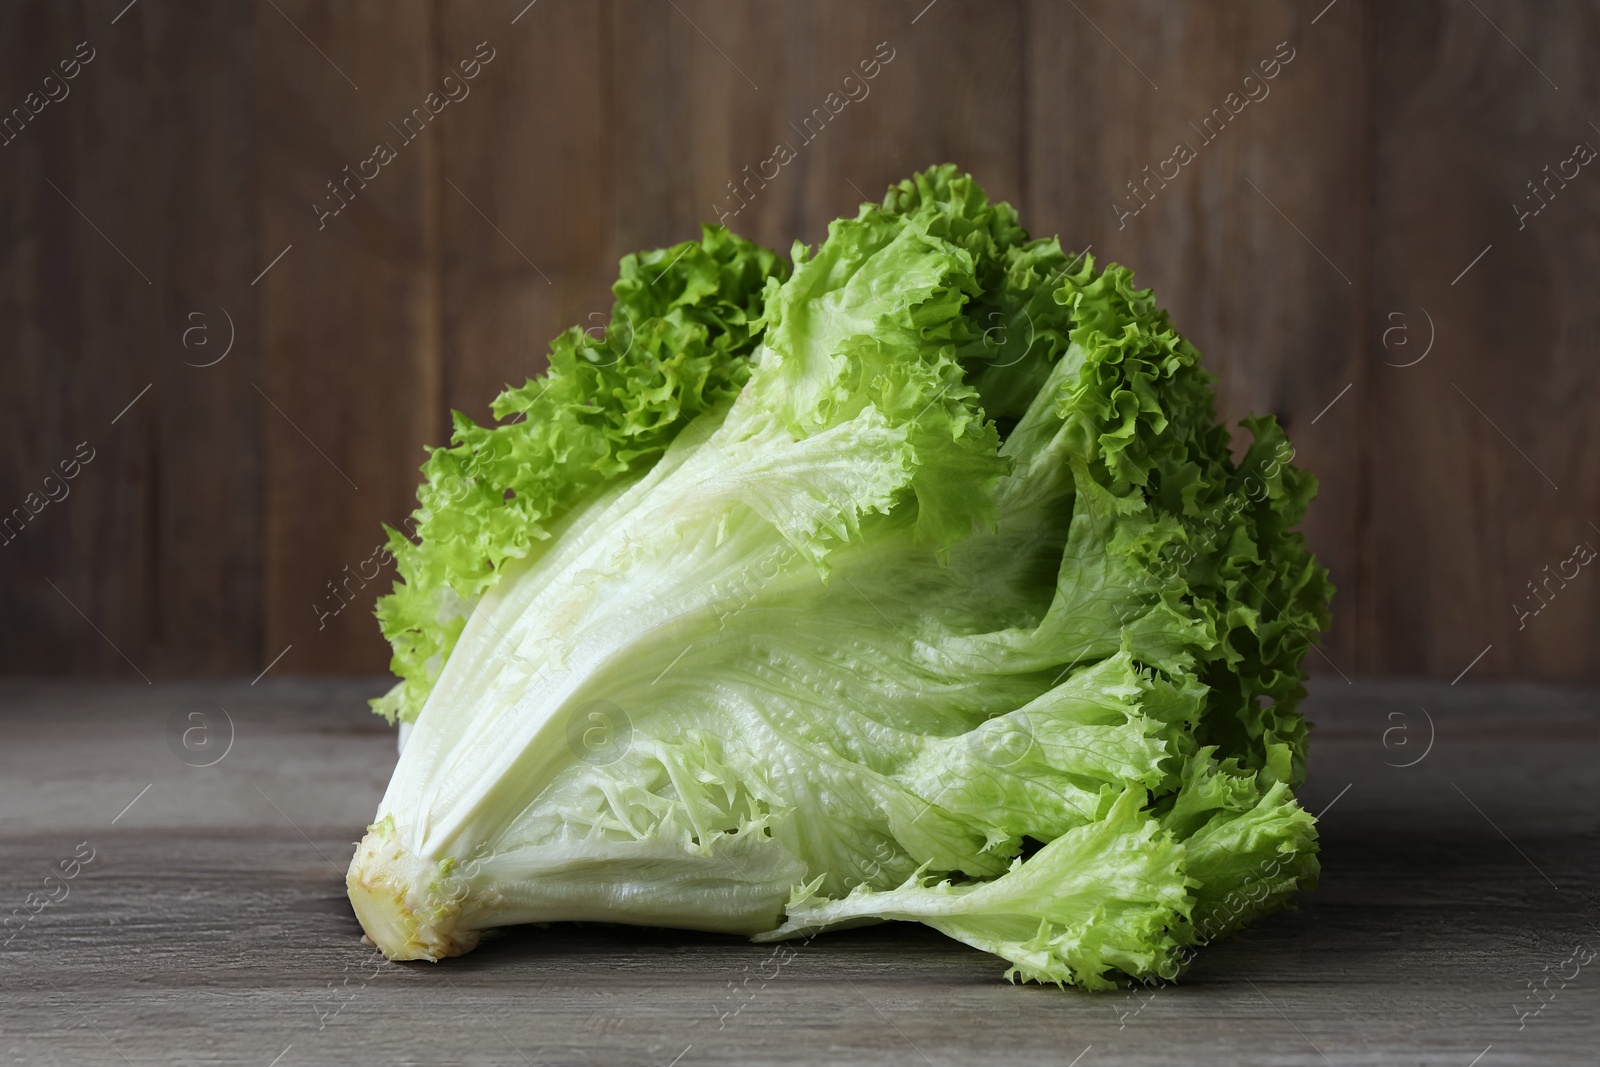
[{"left": 373, "top": 226, "right": 789, "bottom": 721}]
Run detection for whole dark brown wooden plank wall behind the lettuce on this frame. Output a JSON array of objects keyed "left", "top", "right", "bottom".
[{"left": 0, "top": 0, "right": 1600, "bottom": 680}]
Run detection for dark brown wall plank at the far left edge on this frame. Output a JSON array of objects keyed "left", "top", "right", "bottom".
[{"left": 0, "top": 3, "right": 261, "bottom": 675}]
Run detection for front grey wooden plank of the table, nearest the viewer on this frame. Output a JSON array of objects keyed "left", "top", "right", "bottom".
[{"left": 0, "top": 830, "right": 1600, "bottom": 1067}]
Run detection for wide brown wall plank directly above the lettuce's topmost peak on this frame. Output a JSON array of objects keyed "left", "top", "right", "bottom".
[{"left": 613, "top": 0, "right": 1022, "bottom": 253}]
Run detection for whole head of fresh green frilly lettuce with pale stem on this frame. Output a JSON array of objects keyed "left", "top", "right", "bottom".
[{"left": 349, "top": 166, "right": 1331, "bottom": 987}]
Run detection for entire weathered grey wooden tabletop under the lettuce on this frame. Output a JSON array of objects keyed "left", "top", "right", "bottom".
[{"left": 0, "top": 680, "right": 1600, "bottom": 1067}]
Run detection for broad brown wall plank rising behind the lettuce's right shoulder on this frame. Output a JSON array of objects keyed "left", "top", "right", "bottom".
[{"left": 1026, "top": 3, "right": 1379, "bottom": 673}]
